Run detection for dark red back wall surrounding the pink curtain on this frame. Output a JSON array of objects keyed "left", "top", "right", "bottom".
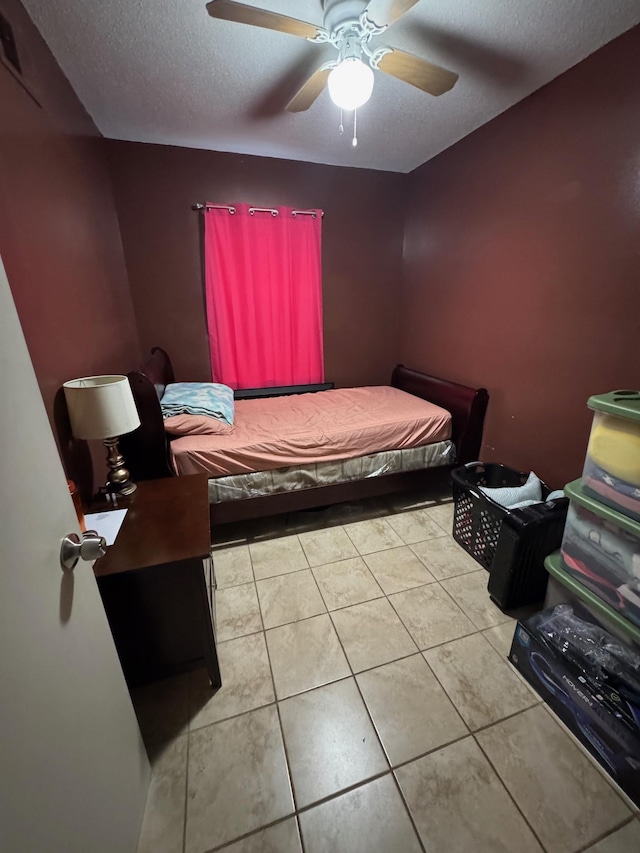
[{"left": 108, "top": 141, "right": 404, "bottom": 385}]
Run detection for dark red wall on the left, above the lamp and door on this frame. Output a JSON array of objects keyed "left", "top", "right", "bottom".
[{"left": 0, "top": 0, "right": 140, "bottom": 424}]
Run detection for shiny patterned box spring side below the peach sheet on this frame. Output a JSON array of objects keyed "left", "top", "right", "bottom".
[{"left": 209, "top": 440, "right": 456, "bottom": 503}]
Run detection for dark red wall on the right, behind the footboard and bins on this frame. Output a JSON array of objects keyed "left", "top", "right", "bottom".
[{"left": 401, "top": 27, "right": 640, "bottom": 484}]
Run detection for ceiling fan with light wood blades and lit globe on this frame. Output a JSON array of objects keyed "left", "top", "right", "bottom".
[{"left": 207, "top": 0, "right": 458, "bottom": 113}]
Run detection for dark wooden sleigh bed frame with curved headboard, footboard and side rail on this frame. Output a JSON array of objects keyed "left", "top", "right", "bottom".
[{"left": 120, "top": 347, "right": 489, "bottom": 528}]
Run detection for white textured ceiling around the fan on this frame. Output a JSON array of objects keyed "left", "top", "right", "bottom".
[{"left": 23, "top": 0, "right": 640, "bottom": 172}]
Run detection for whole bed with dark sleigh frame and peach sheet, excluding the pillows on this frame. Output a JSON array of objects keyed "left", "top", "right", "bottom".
[{"left": 120, "top": 347, "right": 489, "bottom": 525}]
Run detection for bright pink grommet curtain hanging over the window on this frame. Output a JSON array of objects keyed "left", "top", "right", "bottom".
[{"left": 204, "top": 204, "right": 324, "bottom": 388}]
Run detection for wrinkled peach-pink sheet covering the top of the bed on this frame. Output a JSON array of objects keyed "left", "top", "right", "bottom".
[{"left": 171, "top": 386, "right": 451, "bottom": 477}]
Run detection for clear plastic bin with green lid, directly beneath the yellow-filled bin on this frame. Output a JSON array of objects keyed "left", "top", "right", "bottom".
[{"left": 561, "top": 480, "right": 640, "bottom": 625}]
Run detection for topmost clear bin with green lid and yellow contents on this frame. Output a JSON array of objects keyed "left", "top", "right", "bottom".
[{"left": 582, "top": 391, "right": 640, "bottom": 521}]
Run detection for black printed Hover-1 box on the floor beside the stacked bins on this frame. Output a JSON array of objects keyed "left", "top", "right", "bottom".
[{"left": 509, "top": 614, "right": 640, "bottom": 805}]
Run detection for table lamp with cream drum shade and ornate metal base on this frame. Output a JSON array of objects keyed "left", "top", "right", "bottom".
[{"left": 62, "top": 376, "right": 140, "bottom": 495}]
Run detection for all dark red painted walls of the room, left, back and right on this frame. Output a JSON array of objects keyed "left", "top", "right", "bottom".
[{"left": 6, "top": 0, "right": 640, "bottom": 492}]
